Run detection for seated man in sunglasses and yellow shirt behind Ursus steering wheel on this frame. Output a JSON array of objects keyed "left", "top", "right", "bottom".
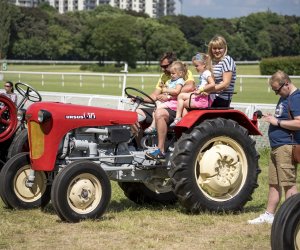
[{"left": 136, "top": 52, "right": 195, "bottom": 162}]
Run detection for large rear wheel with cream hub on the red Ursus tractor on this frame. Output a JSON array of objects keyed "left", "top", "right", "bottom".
[{"left": 169, "top": 118, "right": 260, "bottom": 213}]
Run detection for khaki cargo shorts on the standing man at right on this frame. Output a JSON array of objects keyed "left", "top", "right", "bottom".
[{"left": 269, "top": 145, "right": 297, "bottom": 187}]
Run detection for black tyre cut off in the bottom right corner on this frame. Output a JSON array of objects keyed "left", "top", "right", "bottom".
[{"left": 271, "top": 194, "right": 300, "bottom": 250}]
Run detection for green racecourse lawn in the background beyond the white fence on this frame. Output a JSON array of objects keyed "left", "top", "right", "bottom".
[{"left": 4, "top": 65, "right": 300, "bottom": 103}]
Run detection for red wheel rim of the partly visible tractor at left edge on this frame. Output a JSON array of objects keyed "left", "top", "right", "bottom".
[{"left": 0, "top": 95, "right": 18, "bottom": 142}]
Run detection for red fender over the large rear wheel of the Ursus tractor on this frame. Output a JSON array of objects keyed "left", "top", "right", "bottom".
[{"left": 175, "top": 109, "right": 262, "bottom": 135}]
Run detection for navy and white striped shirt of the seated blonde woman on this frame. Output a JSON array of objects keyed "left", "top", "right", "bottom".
[{"left": 213, "top": 55, "right": 236, "bottom": 100}]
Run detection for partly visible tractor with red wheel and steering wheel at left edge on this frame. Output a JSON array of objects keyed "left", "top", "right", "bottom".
[{"left": 0, "top": 82, "right": 42, "bottom": 170}]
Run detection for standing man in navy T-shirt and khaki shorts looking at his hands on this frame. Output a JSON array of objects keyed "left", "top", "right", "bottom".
[{"left": 248, "top": 71, "right": 300, "bottom": 224}]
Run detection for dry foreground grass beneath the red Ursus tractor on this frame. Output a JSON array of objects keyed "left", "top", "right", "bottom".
[{"left": 0, "top": 150, "right": 288, "bottom": 250}]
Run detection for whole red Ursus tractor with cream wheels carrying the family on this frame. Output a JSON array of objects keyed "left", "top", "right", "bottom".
[{"left": 0, "top": 88, "right": 261, "bottom": 222}]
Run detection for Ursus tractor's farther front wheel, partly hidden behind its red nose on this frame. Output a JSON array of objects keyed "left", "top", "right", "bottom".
[{"left": 0, "top": 152, "right": 51, "bottom": 209}]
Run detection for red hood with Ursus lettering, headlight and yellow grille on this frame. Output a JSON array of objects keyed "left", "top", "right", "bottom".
[{"left": 26, "top": 102, "right": 137, "bottom": 171}]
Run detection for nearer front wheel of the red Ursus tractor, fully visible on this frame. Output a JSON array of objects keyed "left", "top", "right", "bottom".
[{"left": 51, "top": 160, "right": 111, "bottom": 222}]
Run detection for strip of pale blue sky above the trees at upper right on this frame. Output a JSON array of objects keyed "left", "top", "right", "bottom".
[{"left": 176, "top": 0, "right": 300, "bottom": 18}]
